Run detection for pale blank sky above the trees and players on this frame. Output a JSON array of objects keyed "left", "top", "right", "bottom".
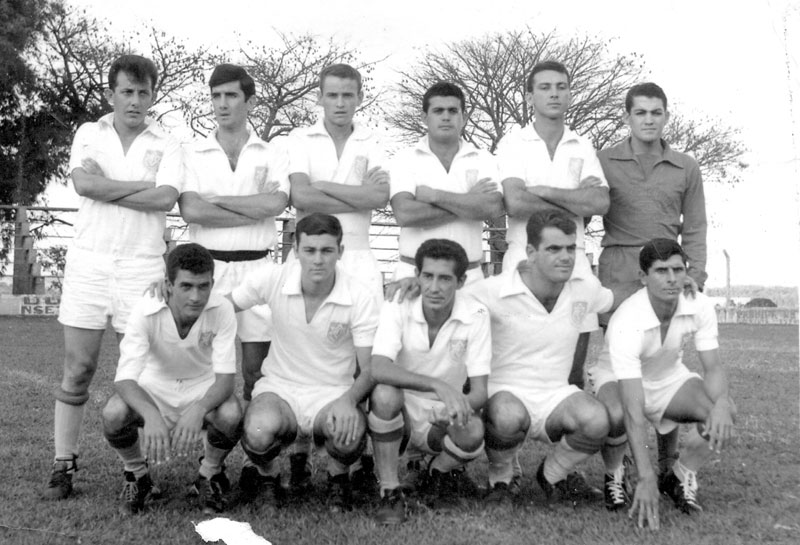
[{"left": 50, "top": 0, "right": 800, "bottom": 287}]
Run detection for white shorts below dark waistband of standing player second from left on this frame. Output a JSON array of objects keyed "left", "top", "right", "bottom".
[{"left": 214, "top": 257, "right": 277, "bottom": 343}]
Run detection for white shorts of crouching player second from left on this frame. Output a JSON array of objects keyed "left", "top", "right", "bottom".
[{"left": 251, "top": 377, "right": 350, "bottom": 437}]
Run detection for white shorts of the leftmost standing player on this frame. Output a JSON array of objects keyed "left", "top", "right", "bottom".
[{"left": 58, "top": 247, "right": 165, "bottom": 333}]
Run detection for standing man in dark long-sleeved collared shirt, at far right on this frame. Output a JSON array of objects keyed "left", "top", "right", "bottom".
[{"left": 598, "top": 83, "right": 708, "bottom": 480}]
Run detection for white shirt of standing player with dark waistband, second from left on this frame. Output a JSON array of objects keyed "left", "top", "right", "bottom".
[{"left": 183, "top": 131, "right": 289, "bottom": 251}]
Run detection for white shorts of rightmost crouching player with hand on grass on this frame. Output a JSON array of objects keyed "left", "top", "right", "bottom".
[{"left": 586, "top": 363, "right": 702, "bottom": 435}]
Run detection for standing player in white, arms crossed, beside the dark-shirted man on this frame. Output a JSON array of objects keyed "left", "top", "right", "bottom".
[{"left": 497, "top": 61, "right": 608, "bottom": 387}]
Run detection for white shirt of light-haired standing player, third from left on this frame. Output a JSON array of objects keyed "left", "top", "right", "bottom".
[{"left": 286, "top": 118, "right": 388, "bottom": 251}]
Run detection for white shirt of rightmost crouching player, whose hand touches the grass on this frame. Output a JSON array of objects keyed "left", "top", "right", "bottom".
[{"left": 597, "top": 288, "right": 719, "bottom": 382}]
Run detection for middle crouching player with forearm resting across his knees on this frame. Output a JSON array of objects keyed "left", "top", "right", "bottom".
[{"left": 369, "top": 239, "right": 492, "bottom": 524}]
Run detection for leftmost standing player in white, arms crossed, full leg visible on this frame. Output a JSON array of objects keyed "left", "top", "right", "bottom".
[{"left": 44, "top": 55, "right": 181, "bottom": 499}]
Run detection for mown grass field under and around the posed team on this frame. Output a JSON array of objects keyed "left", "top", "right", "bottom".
[{"left": 0, "top": 317, "right": 800, "bottom": 545}]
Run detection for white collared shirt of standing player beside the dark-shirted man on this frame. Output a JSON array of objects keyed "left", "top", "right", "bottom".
[{"left": 497, "top": 123, "right": 608, "bottom": 255}]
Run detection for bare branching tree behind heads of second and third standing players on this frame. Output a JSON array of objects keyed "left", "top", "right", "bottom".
[{"left": 182, "top": 32, "right": 379, "bottom": 142}]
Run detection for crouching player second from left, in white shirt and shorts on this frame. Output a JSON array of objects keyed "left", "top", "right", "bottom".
[{"left": 231, "top": 214, "right": 378, "bottom": 511}]
